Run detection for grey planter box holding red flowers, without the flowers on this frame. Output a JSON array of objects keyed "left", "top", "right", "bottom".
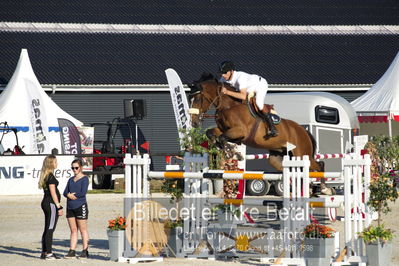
[{"left": 304, "top": 238, "right": 334, "bottom": 266}]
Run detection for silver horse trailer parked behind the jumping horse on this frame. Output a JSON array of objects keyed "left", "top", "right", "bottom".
[{"left": 246, "top": 92, "right": 359, "bottom": 195}]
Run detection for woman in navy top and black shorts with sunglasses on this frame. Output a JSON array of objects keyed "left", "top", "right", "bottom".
[{"left": 64, "top": 159, "right": 89, "bottom": 259}]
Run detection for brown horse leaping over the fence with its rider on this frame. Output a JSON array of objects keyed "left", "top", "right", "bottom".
[{"left": 188, "top": 74, "right": 323, "bottom": 171}]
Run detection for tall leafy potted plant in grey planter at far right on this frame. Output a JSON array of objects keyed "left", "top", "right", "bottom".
[{"left": 359, "top": 136, "right": 399, "bottom": 266}]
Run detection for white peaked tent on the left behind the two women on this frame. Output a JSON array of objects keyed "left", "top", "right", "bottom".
[{"left": 0, "top": 49, "right": 82, "bottom": 154}]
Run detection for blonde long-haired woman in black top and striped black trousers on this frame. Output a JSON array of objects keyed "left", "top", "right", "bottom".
[{"left": 39, "top": 155, "right": 63, "bottom": 260}]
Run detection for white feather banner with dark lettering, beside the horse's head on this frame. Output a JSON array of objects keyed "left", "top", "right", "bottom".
[{"left": 165, "top": 68, "right": 191, "bottom": 149}]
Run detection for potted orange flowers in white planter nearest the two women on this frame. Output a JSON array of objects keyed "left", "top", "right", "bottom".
[{"left": 107, "top": 216, "right": 126, "bottom": 261}]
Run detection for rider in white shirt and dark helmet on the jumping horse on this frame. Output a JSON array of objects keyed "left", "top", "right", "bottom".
[{"left": 219, "top": 61, "right": 278, "bottom": 138}]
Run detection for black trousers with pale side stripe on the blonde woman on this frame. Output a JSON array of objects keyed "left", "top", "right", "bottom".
[{"left": 42, "top": 198, "right": 58, "bottom": 254}]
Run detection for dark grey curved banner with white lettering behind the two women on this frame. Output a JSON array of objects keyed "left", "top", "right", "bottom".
[{"left": 58, "top": 118, "right": 82, "bottom": 154}]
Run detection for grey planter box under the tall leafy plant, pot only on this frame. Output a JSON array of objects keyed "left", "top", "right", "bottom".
[{"left": 366, "top": 241, "right": 392, "bottom": 266}]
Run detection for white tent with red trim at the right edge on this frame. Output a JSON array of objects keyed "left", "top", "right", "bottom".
[{"left": 351, "top": 53, "right": 399, "bottom": 136}]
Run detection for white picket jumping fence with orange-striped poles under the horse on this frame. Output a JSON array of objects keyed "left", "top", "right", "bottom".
[{"left": 121, "top": 151, "right": 371, "bottom": 265}]
